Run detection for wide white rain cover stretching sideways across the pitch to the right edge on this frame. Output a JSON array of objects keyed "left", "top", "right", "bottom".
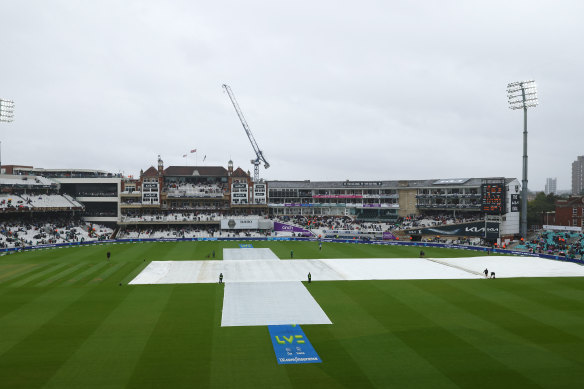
[{"left": 130, "top": 255, "right": 584, "bottom": 284}]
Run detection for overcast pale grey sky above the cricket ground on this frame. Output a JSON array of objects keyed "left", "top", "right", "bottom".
[{"left": 0, "top": 0, "right": 584, "bottom": 189}]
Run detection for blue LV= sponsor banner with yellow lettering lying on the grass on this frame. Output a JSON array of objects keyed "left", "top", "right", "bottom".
[{"left": 268, "top": 325, "right": 322, "bottom": 365}]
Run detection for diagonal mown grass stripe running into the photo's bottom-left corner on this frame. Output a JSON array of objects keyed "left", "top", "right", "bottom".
[{"left": 0, "top": 288, "right": 130, "bottom": 388}]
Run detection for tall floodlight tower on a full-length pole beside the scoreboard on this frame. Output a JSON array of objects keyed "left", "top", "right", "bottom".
[{"left": 507, "top": 80, "right": 537, "bottom": 239}]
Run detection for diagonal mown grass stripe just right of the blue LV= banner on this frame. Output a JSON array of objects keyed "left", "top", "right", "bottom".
[{"left": 310, "top": 281, "right": 457, "bottom": 388}]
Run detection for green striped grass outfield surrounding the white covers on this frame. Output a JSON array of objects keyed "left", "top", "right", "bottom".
[{"left": 0, "top": 242, "right": 584, "bottom": 389}]
